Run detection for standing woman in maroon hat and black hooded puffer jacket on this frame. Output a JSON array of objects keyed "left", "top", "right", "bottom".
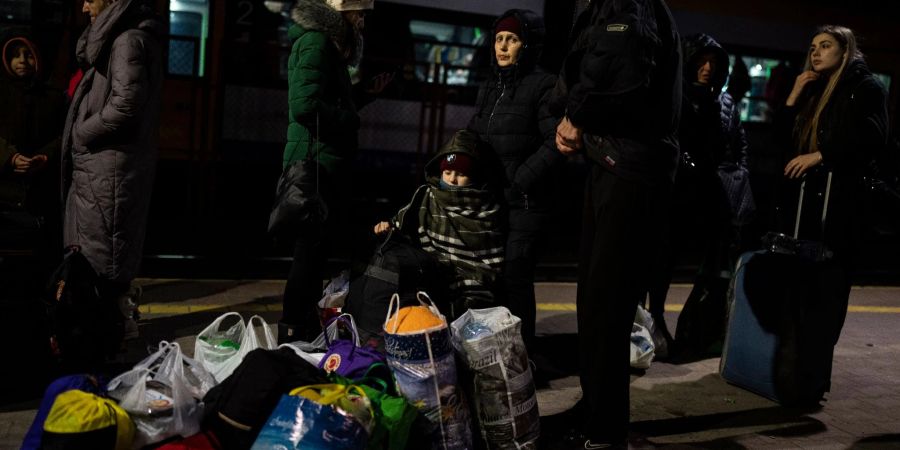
[{"left": 468, "top": 9, "right": 562, "bottom": 351}]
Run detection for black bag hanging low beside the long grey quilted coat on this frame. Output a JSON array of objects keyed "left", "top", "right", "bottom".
[{"left": 45, "top": 246, "right": 125, "bottom": 369}]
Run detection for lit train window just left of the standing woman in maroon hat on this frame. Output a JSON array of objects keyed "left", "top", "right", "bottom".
[{"left": 409, "top": 20, "right": 485, "bottom": 85}]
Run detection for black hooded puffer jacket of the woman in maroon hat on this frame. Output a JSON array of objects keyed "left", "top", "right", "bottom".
[{"left": 468, "top": 9, "right": 562, "bottom": 209}]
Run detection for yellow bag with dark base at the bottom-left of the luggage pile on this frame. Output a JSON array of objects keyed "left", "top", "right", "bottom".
[{"left": 41, "top": 390, "right": 134, "bottom": 450}]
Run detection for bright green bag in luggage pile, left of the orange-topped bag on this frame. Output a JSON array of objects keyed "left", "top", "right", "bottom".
[{"left": 329, "top": 363, "right": 419, "bottom": 450}]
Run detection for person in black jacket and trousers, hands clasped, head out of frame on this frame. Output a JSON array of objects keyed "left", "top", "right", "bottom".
[{"left": 551, "top": 0, "right": 681, "bottom": 448}]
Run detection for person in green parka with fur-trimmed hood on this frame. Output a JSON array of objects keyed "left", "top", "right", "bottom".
[{"left": 278, "top": 0, "right": 390, "bottom": 342}]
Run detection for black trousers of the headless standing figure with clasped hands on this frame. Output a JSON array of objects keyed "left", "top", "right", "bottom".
[{"left": 577, "top": 164, "right": 671, "bottom": 443}]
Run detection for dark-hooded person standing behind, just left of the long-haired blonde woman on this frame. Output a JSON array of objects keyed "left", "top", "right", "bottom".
[{"left": 650, "top": 33, "right": 753, "bottom": 356}]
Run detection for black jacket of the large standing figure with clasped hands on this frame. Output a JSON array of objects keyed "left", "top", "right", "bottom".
[{"left": 551, "top": 0, "right": 681, "bottom": 184}]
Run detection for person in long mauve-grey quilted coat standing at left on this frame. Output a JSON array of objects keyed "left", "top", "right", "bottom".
[{"left": 62, "top": 0, "right": 166, "bottom": 324}]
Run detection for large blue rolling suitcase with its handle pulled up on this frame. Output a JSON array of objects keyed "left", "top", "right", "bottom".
[{"left": 719, "top": 173, "right": 847, "bottom": 406}]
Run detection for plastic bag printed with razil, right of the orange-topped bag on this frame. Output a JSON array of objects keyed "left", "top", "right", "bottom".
[{"left": 450, "top": 306, "right": 541, "bottom": 449}]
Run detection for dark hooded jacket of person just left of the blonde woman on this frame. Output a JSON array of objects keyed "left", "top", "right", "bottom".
[{"left": 679, "top": 33, "right": 748, "bottom": 170}]
